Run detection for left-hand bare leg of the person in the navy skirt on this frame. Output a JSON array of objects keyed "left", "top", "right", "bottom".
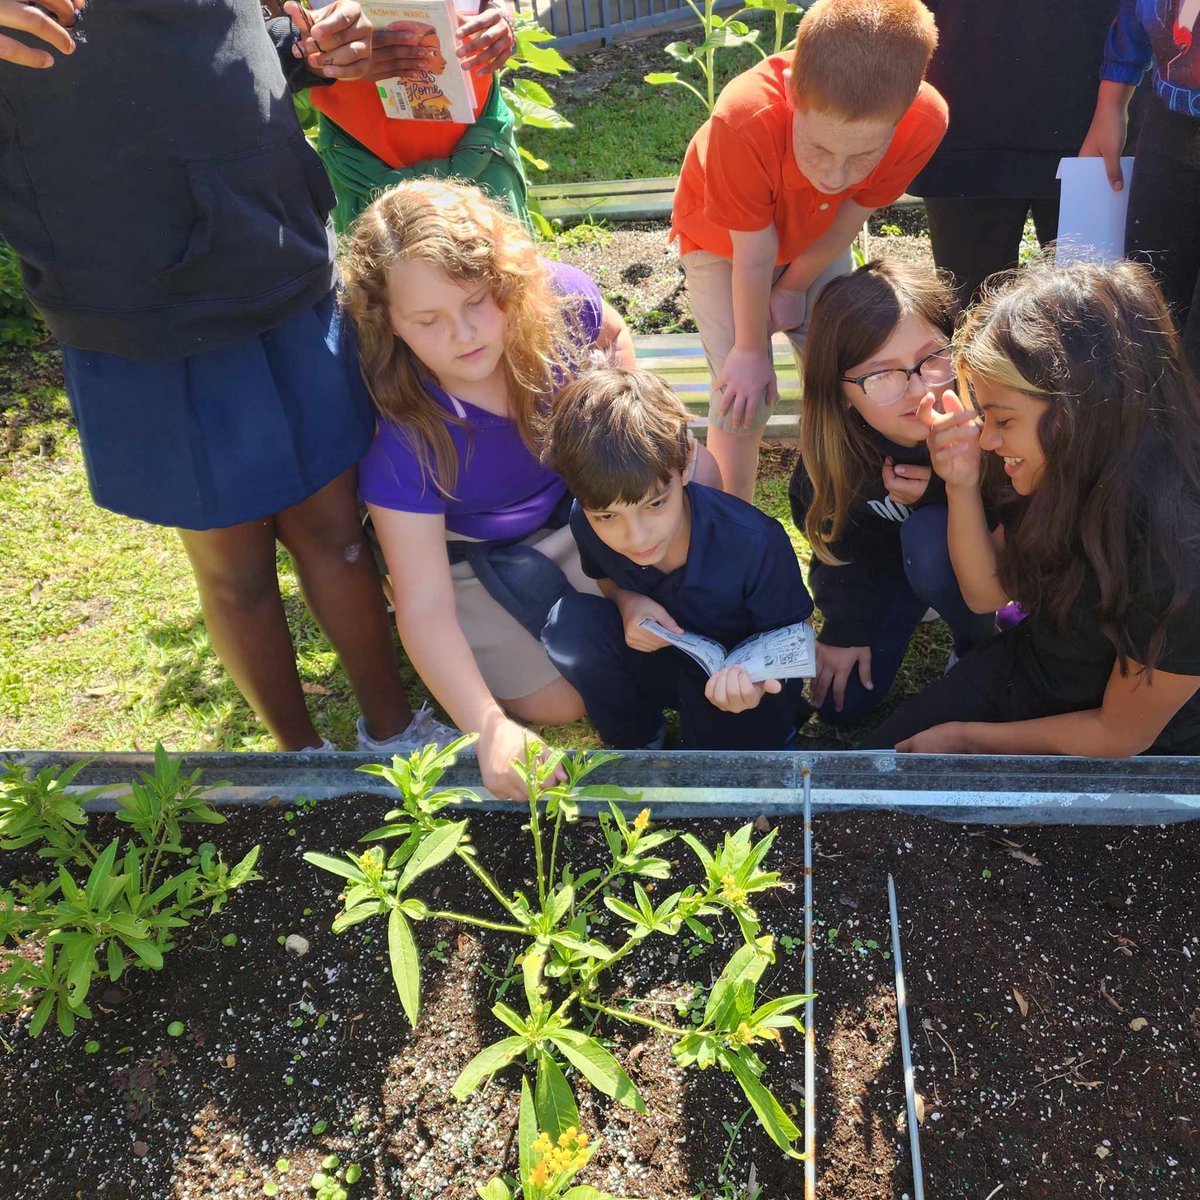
[{"left": 179, "top": 517, "right": 320, "bottom": 750}]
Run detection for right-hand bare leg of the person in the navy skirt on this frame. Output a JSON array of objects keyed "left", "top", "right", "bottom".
[{"left": 275, "top": 468, "right": 413, "bottom": 740}]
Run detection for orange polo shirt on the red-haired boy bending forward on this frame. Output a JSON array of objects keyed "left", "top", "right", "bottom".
[{"left": 671, "top": 54, "right": 949, "bottom": 264}]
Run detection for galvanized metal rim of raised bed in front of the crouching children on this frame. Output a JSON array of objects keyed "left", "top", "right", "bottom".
[{"left": 7, "top": 750, "right": 1200, "bottom": 824}]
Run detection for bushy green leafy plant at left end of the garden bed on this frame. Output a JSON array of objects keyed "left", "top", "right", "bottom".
[{"left": 0, "top": 745, "right": 262, "bottom": 1038}]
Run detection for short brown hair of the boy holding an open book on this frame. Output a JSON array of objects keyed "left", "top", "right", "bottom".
[{"left": 542, "top": 367, "right": 691, "bottom": 510}]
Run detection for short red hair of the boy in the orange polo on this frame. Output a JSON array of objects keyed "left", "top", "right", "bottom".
[{"left": 788, "top": 0, "right": 937, "bottom": 121}]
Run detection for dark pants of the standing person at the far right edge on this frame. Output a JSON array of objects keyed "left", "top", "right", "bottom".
[{"left": 1126, "top": 98, "right": 1200, "bottom": 371}]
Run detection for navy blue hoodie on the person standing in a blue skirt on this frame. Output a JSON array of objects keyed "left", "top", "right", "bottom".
[{"left": 0, "top": 0, "right": 335, "bottom": 359}]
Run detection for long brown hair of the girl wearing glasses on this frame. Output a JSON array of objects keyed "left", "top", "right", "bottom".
[{"left": 800, "top": 262, "right": 956, "bottom": 566}]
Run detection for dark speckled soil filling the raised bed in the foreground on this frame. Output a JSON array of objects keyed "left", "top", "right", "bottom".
[{"left": 0, "top": 798, "right": 1200, "bottom": 1200}]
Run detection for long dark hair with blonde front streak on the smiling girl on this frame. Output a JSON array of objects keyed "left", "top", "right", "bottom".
[{"left": 955, "top": 262, "right": 1200, "bottom": 673}]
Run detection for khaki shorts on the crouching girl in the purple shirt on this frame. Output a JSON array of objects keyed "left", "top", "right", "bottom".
[{"left": 450, "top": 526, "right": 600, "bottom": 701}]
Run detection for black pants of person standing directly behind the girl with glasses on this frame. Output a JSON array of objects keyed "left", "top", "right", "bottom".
[{"left": 925, "top": 196, "right": 1058, "bottom": 306}]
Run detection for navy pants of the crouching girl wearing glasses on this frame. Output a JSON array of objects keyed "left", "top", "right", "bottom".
[{"left": 818, "top": 505, "right": 996, "bottom": 725}]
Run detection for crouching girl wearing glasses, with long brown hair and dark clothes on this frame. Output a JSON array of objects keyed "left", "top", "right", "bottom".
[{"left": 788, "top": 263, "right": 995, "bottom": 725}]
